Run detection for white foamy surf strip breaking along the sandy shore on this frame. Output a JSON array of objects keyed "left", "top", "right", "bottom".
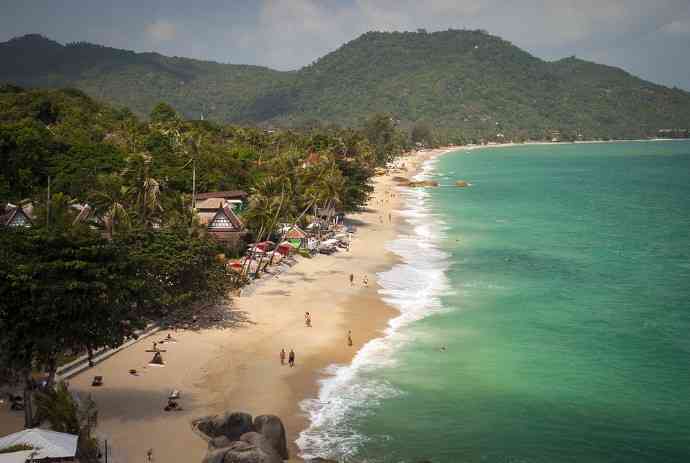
[{"left": 296, "top": 155, "right": 448, "bottom": 460}]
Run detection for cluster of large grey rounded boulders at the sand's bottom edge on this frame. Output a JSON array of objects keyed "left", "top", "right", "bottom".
[{"left": 196, "top": 413, "right": 289, "bottom": 463}]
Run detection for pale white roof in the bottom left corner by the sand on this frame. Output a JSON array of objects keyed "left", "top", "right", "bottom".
[{"left": 0, "top": 428, "right": 79, "bottom": 463}]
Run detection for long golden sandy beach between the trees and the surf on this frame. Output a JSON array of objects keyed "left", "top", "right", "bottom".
[{"left": 0, "top": 149, "right": 450, "bottom": 463}]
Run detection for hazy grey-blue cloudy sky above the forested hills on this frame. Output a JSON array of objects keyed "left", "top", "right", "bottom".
[{"left": 0, "top": 0, "right": 690, "bottom": 90}]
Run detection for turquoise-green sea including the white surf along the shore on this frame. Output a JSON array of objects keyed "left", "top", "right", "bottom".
[{"left": 298, "top": 141, "right": 690, "bottom": 463}]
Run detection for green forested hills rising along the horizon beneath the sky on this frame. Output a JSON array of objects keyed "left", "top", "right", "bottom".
[{"left": 0, "top": 30, "right": 690, "bottom": 138}]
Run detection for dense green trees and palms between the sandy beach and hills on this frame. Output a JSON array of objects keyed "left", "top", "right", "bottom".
[{"left": 0, "top": 86, "right": 406, "bottom": 430}]
